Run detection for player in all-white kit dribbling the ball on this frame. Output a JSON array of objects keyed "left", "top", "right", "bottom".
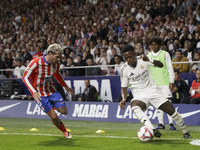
[{"left": 120, "top": 45, "right": 191, "bottom": 138}]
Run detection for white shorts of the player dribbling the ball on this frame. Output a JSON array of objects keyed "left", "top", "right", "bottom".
[{"left": 131, "top": 88, "right": 168, "bottom": 108}]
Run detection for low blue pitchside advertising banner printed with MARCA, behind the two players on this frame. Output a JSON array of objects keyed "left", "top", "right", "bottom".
[{"left": 0, "top": 100, "right": 200, "bottom": 125}]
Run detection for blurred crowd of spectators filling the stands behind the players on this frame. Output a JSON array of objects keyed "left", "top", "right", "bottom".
[{"left": 0, "top": 0, "right": 200, "bottom": 78}]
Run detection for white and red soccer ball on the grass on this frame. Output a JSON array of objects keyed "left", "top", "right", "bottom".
[{"left": 138, "top": 126, "right": 154, "bottom": 142}]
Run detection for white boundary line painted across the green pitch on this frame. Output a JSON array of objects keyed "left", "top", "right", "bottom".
[{"left": 0, "top": 133, "right": 199, "bottom": 140}]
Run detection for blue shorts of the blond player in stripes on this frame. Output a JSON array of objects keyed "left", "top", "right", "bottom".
[{"left": 36, "top": 91, "right": 66, "bottom": 113}]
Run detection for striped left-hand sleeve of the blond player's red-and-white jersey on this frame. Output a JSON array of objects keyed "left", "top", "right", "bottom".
[{"left": 22, "top": 60, "right": 37, "bottom": 95}]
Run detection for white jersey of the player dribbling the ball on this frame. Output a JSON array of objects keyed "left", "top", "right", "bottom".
[{"left": 120, "top": 59, "right": 157, "bottom": 95}]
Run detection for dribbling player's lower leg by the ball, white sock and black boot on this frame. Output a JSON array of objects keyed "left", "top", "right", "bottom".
[{"left": 131, "top": 106, "right": 162, "bottom": 138}]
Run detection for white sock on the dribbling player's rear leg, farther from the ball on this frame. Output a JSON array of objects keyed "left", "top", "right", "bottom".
[{"left": 171, "top": 111, "right": 188, "bottom": 133}]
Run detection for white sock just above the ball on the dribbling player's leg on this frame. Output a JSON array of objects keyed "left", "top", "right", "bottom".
[{"left": 131, "top": 106, "right": 155, "bottom": 129}]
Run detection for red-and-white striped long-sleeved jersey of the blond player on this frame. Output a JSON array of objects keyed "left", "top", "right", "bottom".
[{"left": 22, "top": 56, "right": 67, "bottom": 97}]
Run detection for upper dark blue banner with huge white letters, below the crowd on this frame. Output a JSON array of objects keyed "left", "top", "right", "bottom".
[{"left": 0, "top": 73, "right": 196, "bottom": 101}]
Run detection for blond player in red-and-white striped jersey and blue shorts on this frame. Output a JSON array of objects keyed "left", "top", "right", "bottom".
[{"left": 22, "top": 44, "right": 74, "bottom": 138}]
